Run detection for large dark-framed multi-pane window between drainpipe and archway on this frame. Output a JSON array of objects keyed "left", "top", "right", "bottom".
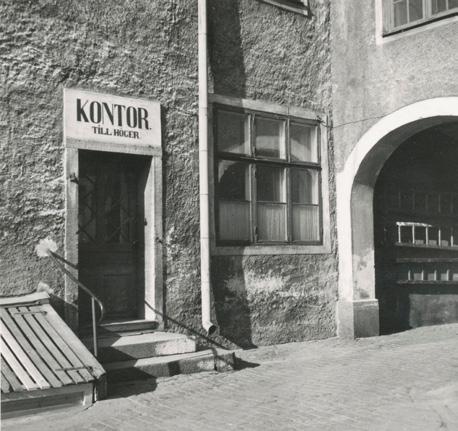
[{"left": 214, "top": 105, "right": 322, "bottom": 244}]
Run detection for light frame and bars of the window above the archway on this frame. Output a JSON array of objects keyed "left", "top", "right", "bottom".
[{"left": 381, "top": 0, "right": 458, "bottom": 37}]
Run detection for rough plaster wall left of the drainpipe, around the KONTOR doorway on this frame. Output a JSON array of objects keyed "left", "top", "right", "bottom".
[{"left": 0, "top": 0, "right": 200, "bottom": 322}]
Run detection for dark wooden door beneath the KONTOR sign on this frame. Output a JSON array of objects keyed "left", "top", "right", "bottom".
[{"left": 78, "top": 151, "right": 145, "bottom": 326}]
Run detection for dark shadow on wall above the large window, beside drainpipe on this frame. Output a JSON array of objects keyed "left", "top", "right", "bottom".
[{"left": 208, "top": 0, "right": 246, "bottom": 97}]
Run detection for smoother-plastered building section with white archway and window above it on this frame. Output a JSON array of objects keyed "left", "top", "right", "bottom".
[{"left": 331, "top": 0, "right": 458, "bottom": 336}]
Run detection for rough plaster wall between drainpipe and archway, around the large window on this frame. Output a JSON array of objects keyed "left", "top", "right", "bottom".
[{"left": 209, "top": 0, "right": 337, "bottom": 346}]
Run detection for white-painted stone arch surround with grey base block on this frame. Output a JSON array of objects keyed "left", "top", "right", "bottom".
[{"left": 336, "top": 97, "right": 458, "bottom": 337}]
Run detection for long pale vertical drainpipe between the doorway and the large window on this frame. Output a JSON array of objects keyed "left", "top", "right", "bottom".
[{"left": 198, "top": 0, "right": 216, "bottom": 334}]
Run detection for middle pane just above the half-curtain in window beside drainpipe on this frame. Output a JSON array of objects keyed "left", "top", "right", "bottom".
[{"left": 256, "top": 165, "right": 286, "bottom": 202}]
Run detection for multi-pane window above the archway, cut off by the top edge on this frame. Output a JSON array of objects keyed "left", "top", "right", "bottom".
[{"left": 383, "top": 0, "right": 458, "bottom": 33}]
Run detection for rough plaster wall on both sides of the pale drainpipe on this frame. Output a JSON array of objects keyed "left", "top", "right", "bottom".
[{"left": 0, "top": 0, "right": 336, "bottom": 345}]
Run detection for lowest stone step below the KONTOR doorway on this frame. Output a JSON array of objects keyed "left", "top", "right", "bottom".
[{"left": 104, "top": 349, "right": 235, "bottom": 383}]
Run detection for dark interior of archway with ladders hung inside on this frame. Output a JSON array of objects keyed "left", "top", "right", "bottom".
[{"left": 374, "top": 123, "right": 458, "bottom": 333}]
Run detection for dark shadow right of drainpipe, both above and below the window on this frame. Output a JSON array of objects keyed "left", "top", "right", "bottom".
[{"left": 208, "top": 0, "right": 250, "bottom": 349}]
